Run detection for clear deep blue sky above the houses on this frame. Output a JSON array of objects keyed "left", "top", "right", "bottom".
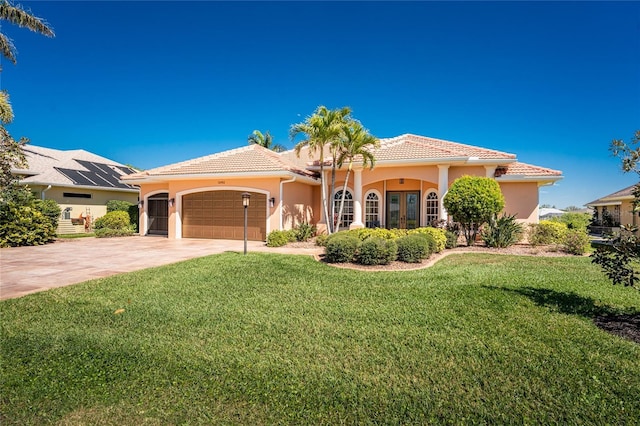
[{"left": 1, "top": 1, "right": 640, "bottom": 207}]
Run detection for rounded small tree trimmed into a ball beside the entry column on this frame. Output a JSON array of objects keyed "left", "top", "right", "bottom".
[{"left": 442, "top": 176, "right": 504, "bottom": 245}]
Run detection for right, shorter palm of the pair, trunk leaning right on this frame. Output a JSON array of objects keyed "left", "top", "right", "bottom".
[{"left": 336, "top": 120, "right": 380, "bottom": 229}]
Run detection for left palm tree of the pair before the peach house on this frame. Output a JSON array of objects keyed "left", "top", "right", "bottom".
[{"left": 289, "top": 105, "right": 351, "bottom": 234}]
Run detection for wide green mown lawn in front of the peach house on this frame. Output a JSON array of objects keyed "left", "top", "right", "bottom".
[{"left": 0, "top": 253, "right": 640, "bottom": 425}]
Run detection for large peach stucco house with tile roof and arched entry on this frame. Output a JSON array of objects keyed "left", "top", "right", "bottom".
[{"left": 122, "top": 134, "right": 562, "bottom": 240}]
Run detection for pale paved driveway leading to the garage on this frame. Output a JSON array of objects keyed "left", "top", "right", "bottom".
[{"left": 0, "top": 236, "right": 320, "bottom": 300}]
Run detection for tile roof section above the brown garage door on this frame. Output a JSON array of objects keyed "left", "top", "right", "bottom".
[{"left": 123, "top": 144, "right": 314, "bottom": 180}]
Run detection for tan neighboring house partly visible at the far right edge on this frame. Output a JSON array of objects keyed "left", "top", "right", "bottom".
[{"left": 585, "top": 185, "right": 638, "bottom": 233}]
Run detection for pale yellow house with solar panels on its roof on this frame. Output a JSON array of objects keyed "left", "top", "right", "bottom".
[{"left": 12, "top": 145, "right": 140, "bottom": 234}]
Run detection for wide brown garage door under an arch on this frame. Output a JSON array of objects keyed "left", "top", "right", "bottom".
[{"left": 182, "top": 191, "right": 267, "bottom": 241}]
